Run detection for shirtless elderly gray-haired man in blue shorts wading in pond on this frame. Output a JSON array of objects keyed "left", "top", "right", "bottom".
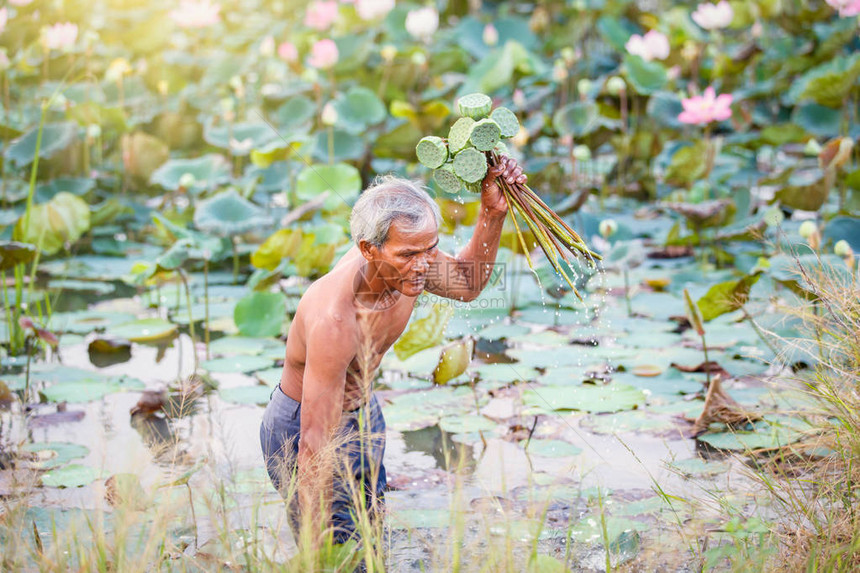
[{"left": 260, "top": 157, "right": 526, "bottom": 545}]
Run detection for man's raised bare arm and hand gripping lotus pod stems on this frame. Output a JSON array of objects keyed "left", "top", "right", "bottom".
[{"left": 425, "top": 156, "right": 526, "bottom": 301}]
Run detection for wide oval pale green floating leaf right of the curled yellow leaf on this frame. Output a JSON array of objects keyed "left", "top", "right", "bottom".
[{"left": 523, "top": 384, "right": 645, "bottom": 413}]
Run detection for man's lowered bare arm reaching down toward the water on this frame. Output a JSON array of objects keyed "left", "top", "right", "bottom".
[{"left": 298, "top": 314, "right": 356, "bottom": 541}]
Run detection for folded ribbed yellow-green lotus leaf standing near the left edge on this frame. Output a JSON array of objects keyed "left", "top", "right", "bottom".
[{"left": 13, "top": 191, "right": 90, "bottom": 255}]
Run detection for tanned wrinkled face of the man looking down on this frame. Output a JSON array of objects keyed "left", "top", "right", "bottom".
[{"left": 375, "top": 214, "right": 439, "bottom": 296}]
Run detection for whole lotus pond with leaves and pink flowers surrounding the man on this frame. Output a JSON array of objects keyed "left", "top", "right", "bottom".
[{"left": 0, "top": 0, "right": 860, "bottom": 571}]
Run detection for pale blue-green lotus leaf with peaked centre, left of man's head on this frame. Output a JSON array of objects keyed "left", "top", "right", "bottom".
[{"left": 194, "top": 189, "right": 272, "bottom": 233}]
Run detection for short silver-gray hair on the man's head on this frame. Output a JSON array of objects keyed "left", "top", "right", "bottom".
[{"left": 349, "top": 175, "right": 442, "bottom": 247}]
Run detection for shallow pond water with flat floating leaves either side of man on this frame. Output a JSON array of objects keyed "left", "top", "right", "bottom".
[{"left": 0, "top": 254, "right": 797, "bottom": 571}]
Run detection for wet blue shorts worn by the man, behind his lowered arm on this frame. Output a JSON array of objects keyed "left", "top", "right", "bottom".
[{"left": 260, "top": 385, "right": 387, "bottom": 543}]
